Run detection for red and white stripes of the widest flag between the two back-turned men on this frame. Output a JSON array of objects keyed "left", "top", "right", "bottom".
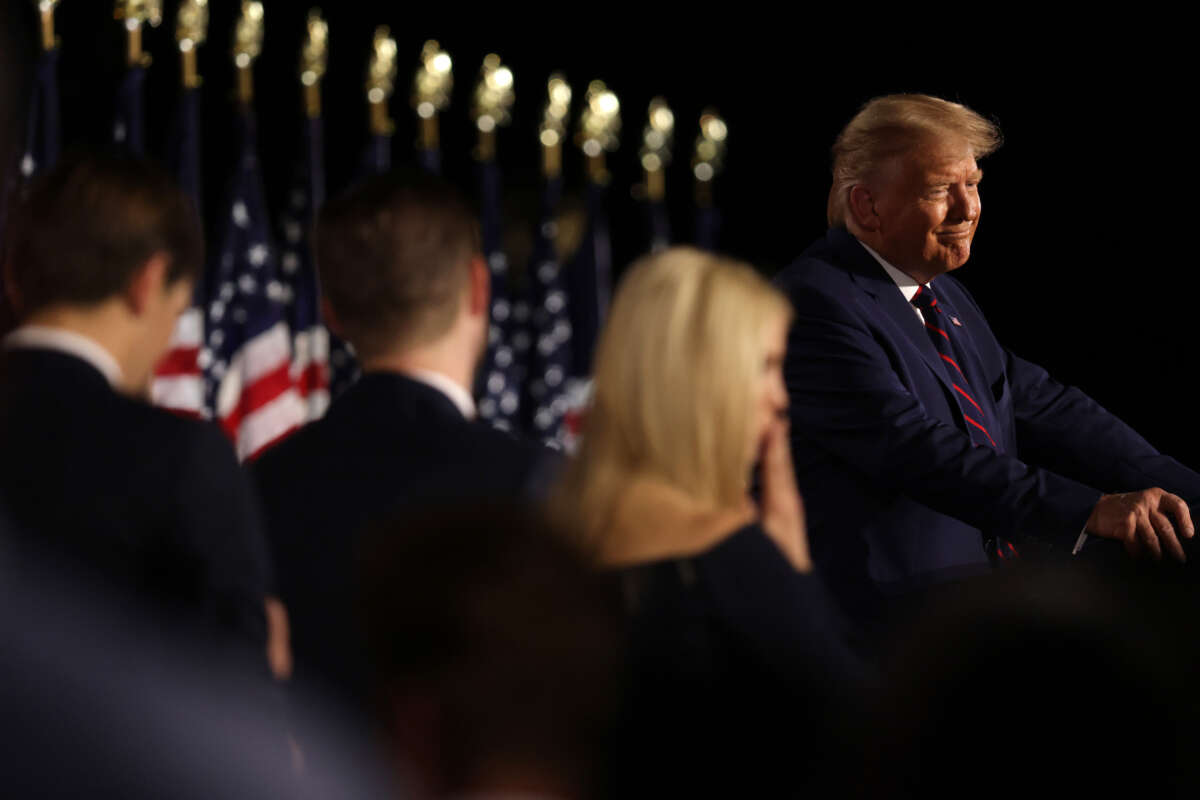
[{"left": 216, "top": 321, "right": 308, "bottom": 461}]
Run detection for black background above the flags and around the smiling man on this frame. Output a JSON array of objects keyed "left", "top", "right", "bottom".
[{"left": 11, "top": 0, "right": 1200, "bottom": 467}]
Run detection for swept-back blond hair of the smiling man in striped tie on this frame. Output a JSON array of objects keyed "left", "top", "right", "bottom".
[{"left": 827, "top": 95, "right": 1001, "bottom": 228}]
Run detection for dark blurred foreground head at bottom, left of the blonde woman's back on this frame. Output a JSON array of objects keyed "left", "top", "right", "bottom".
[{"left": 359, "top": 504, "right": 620, "bottom": 798}]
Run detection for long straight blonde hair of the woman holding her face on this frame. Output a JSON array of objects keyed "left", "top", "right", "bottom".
[{"left": 559, "top": 247, "right": 791, "bottom": 540}]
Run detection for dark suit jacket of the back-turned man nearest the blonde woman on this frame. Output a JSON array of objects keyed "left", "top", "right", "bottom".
[{"left": 251, "top": 372, "right": 558, "bottom": 703}]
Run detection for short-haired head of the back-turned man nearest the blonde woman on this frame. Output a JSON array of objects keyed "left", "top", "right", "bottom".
[{"left": 316, "top": 173, "right": 487, "bottom": 376}]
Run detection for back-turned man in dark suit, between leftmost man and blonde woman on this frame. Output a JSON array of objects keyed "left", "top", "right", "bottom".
[{"left": 253, "top": 174, "right": 550, "bottom": 699}]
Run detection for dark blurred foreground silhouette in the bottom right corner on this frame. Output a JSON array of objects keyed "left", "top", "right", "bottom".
[{"left": 868, "top": 565, "right": 1200, "bottom": 800}]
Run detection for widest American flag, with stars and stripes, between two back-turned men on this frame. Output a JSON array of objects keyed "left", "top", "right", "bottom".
[{"left": 199, "top": 108, "right": 307, "bottom": 459}]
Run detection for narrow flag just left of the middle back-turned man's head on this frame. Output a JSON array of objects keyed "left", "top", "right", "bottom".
[{"left": 280, "top": 116, "right": 330, "bottom": 420}]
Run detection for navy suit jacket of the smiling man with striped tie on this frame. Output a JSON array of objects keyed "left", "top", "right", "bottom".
[{"left": 775, "top": 228, "right": 1200, "bottom": 621}]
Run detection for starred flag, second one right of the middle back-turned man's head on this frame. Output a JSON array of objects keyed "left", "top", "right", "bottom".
[{"left": 528, "top": 178, "right": 571, "bottom": 447}]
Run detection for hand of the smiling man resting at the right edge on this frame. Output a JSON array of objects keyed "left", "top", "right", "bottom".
[{"left": 1087, "top": 488, "right": 1195, "bottom": 561}]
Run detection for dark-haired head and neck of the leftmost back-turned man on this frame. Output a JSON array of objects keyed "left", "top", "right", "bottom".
[{"left": 5, "top": 151, "right": 204, "bottom": 391}]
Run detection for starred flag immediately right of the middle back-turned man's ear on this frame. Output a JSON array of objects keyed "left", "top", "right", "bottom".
[{"left": 476, "top": 158, "right": 529, "bottom": 431}]
